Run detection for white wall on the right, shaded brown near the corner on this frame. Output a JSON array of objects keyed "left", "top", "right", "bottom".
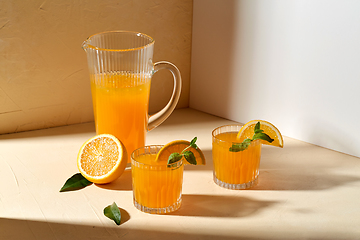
[{"left": 190, "top": 0, "right": 360, "bottom": 157}]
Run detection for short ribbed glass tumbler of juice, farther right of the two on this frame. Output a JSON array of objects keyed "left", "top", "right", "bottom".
[{"left": 212, "top": 125, "right": 261, "bottom": 189}]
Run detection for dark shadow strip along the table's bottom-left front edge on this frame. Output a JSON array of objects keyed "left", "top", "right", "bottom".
[{"left": 0, "top": 217, "right": 265, "bottom": 240}]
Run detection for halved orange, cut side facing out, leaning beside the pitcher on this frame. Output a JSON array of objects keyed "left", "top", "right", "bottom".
[{"left": 77, "top": 134, "right": 127, "bottom": 184}]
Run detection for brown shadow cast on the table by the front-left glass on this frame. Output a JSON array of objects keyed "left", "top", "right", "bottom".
[{"left": 170, "top": 194, "right": 279, "bottom": 218}]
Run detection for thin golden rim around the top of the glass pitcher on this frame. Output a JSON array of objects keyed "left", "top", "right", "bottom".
[{"left": 82, "top": 30, "right": 155, "bottom": 52}]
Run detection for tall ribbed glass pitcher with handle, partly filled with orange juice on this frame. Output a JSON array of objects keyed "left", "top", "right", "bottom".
[{"left": 83, "top": 31, "right": 181, "bottom": 163}]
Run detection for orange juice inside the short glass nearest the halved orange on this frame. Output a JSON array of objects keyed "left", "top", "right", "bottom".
[{"left": 131, "top": 154, "right": 184, "bottom": 208}]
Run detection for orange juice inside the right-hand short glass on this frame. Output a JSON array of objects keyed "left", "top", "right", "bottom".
[{"left": 212, "top": 132, "right": 261, "bottom": 184}]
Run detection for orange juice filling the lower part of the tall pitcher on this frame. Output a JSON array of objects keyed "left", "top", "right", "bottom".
[{"left": 91, "top": 73, "right": 151, "bottom": 162}]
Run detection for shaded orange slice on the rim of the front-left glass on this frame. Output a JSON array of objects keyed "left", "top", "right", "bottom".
[{"left": 155, "top": 140, "right": 206, "bottom": 165}]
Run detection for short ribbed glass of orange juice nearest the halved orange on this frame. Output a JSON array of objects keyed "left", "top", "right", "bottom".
[{"left": 131, "top": 145, "right": 184, "bottom": 214}]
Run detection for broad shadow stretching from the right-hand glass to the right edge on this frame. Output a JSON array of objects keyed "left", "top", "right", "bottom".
[{"left": 252, "top": 144, "right": 360, "bottom": 190}]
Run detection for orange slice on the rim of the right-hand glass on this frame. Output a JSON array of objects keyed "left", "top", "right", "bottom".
[{"left": 237, "top": 120, "right": 284, "bottom": 148}]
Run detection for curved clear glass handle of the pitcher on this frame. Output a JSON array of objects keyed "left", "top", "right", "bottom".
[{"left": 148, "top": 61, "right": 181, "bottom": 131}]
